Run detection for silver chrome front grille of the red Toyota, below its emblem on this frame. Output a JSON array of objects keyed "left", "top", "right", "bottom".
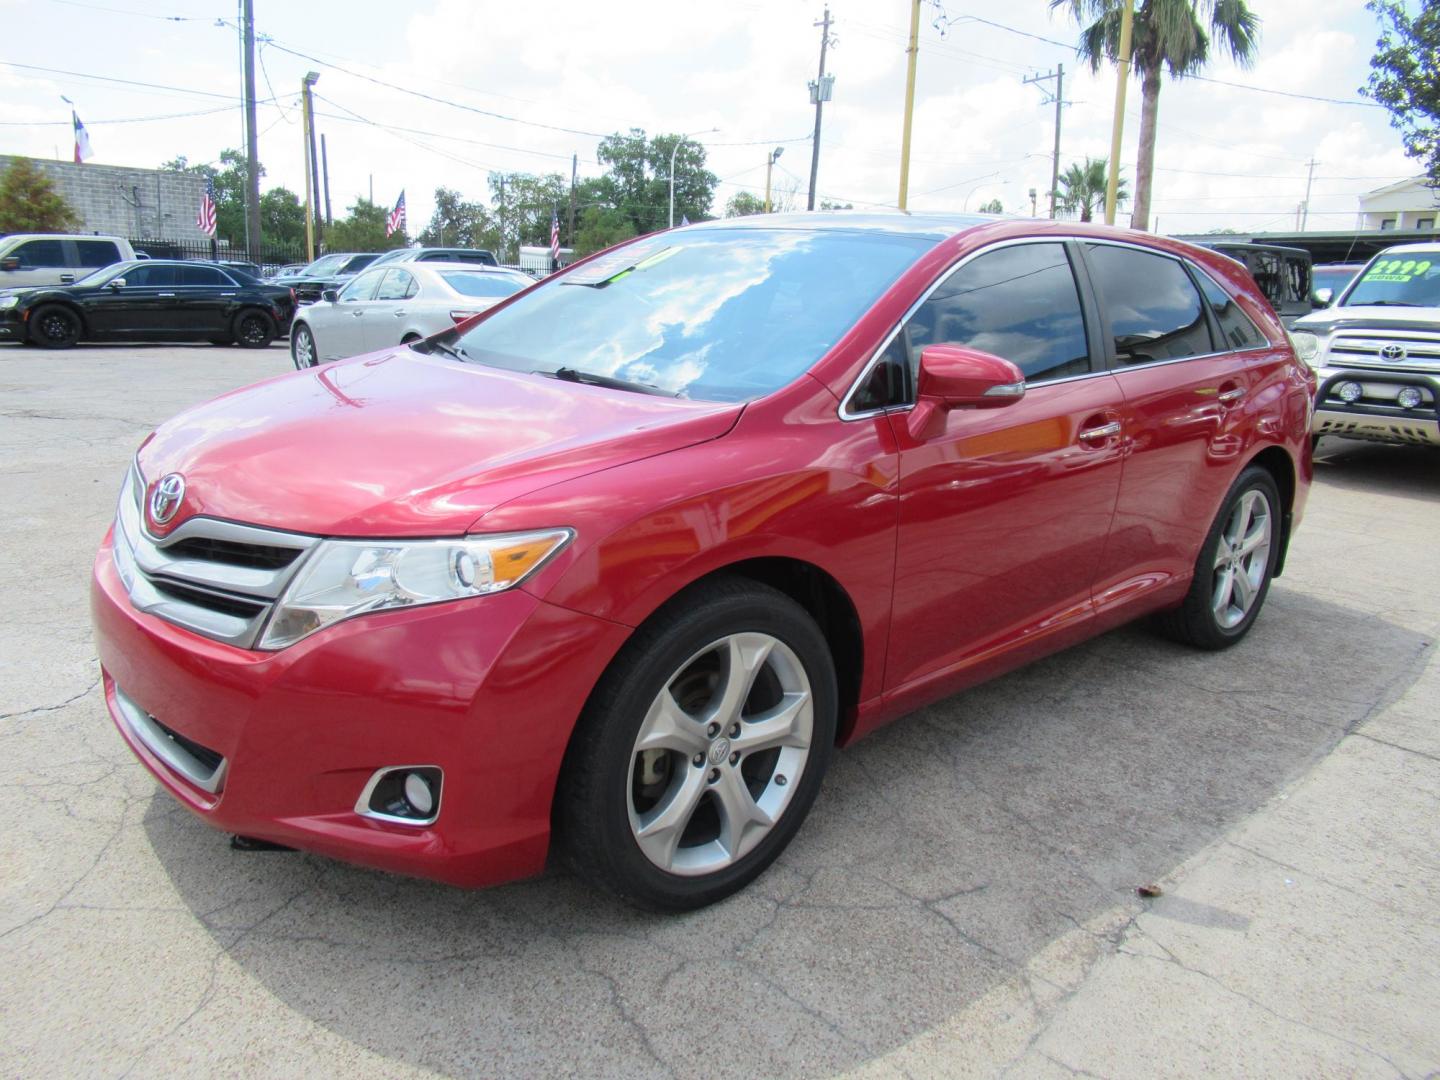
[{"left": 115, "top": 468, "right": 318, "bottom": 648}]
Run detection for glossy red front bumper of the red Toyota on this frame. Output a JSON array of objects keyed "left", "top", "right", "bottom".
[{"left": 91, "top": 536, "right": 629, "bottom": 886}]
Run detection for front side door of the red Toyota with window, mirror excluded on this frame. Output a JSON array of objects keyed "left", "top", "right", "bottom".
[{"left": 886, "top": 239, "right": 1122, "bottom": 690}]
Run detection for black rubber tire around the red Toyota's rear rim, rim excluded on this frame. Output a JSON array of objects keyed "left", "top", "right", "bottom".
[{"left": 1153, "top": 465, "right": 1283, "bottom": 649}]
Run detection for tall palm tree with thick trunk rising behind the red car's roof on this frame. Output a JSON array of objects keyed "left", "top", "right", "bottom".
[{"left": 1050, "top": 0, "right": 1260, "bottom": 229}]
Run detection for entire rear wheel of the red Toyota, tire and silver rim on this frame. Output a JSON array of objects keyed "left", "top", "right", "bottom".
[{"left": 1156, "top": 465, "right": 1282, "bottom": 649}]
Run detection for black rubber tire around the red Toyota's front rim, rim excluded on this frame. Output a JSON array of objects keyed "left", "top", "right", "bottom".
[{"left": 554, "top": 577, "right": 838, "bottom": 912}]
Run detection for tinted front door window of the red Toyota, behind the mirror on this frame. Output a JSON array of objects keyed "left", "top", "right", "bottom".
[{"left": 906, "top": 243, "right": 1088, "bottom": 383}]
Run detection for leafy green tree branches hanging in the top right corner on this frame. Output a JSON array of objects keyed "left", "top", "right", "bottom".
[{"left": 1361, "top": 0, "right": 1440, "bottom": 183}]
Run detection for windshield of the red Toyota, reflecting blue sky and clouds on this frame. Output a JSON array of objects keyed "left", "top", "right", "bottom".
[{"left": 456, "top": 229, "right": 935, "bottom": 402}]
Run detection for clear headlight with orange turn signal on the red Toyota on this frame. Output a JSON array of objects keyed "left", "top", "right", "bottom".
[{"left": 259, "top": 528, "right": 573, "bottom": 649}]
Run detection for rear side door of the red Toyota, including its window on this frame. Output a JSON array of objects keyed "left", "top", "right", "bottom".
[{"left": 1083, "top": 240, "right": 1269, "bottom": 611}]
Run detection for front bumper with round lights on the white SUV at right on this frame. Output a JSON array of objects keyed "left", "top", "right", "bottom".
[{"left": 1310, "top": 366, "right": 1440, "bottom": 446}]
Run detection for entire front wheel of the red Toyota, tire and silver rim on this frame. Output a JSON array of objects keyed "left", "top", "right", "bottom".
[{"left": 556, "top": 579, "right": 837, "bottom": 912}]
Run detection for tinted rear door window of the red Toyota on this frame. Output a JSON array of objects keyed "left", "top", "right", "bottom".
[{"left": 1087, "top": 243, "right": 1214, "bottom": 364}]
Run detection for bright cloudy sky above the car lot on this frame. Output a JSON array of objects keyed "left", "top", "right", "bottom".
[{"left": 0, "top": 0, "right": 1420, "bottom": 233}]
